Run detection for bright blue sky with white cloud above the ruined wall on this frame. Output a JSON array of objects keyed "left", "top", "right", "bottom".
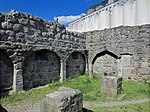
[{"left": 0, "top": 0, "right": 102, "bottom": 24}]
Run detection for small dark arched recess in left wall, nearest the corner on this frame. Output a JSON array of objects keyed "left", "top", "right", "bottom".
[{"left": 66, "top": 52, "right": 86, "bottom": 78}]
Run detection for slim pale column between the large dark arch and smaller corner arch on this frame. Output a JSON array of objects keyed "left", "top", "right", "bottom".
[{"left": 60, "top": 59, "right": 66, "bottom": 82}]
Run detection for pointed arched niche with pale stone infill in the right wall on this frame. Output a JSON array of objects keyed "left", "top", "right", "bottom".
[{"left": 92, "top": 51, "right": 118, "bottom": 75}]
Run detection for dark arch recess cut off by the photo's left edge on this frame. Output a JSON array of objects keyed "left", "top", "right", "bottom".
[{"left": 0, "top": 49, "right": 13, "bottom": 95}]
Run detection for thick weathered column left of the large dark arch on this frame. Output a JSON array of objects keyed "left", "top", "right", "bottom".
[{"left": 13, "top": 62, "right": 23, "bottom": 92}]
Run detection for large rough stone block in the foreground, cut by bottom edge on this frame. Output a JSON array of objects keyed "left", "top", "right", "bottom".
[{"left": 41, "top": 87, "right": 83, "bottom": 112}]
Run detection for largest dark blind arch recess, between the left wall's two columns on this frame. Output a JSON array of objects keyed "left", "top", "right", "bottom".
[{"left": 23, "top": 49, "right": 60, "bottom": 90}]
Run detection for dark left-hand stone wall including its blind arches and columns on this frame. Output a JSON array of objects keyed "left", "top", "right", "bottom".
[{"left": 0, "top": 11, "right": 87, "bottom": 91}]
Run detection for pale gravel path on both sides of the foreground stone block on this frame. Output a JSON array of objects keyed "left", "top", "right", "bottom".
[{"left": 0, "top": 98, "right": 150, "bottom": 112}]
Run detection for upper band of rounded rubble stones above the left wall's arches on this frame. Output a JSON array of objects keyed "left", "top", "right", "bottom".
[{"left": 0, "top": 11, "right": 85, "bottom": 49}]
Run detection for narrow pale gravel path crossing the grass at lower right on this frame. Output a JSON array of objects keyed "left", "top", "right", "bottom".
[{"left": 94, "top": 98, "right": 150, "bottom": 107}]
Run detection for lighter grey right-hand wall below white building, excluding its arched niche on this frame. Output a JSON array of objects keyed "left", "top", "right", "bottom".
[{"left": 85, "top": 25, "right": 150, "bottom": 80}]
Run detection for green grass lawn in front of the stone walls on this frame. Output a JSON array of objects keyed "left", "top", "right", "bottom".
[{"left": 0, "top": 75, "right": 150, "bottom": 112}]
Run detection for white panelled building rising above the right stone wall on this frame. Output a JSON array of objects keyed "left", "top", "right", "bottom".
[{"left": 67, "top": 0, "right": 150, "bottom": 32}]
